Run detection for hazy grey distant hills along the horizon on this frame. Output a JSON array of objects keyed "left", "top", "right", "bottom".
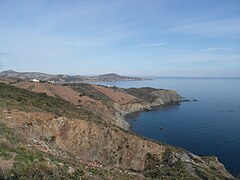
[{"left": 0, "top": 70, "right": 148, "bottom": 83}]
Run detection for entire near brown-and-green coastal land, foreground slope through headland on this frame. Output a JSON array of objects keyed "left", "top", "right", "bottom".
[{"left": 0, "top": 83, "right": 233, "bottom": 179}]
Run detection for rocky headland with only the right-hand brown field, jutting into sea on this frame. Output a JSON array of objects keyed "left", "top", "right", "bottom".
[{"left": 70, "top": 84, "right": 182, "bottom": 130}]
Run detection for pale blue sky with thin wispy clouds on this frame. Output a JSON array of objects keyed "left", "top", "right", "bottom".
[{"left": 0, "top": 0, "right": 240, "bottom": 77}]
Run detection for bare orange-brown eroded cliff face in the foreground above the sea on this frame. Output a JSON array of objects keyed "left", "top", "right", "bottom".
[{"left": 0, "top": 110, "right": 232, "bottom": 179}]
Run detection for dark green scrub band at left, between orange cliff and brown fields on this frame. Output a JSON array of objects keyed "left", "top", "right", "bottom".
[{"left": 0, "top": 83, "right": 101, "bottom": 121}]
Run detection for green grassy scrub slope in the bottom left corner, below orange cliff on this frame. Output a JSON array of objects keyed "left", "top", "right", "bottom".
[{"left": 0, "top": 123, "right": 141, "bottom": 179}]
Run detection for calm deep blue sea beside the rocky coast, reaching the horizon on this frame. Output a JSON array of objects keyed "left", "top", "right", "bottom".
[{"left": 97, "top": 78, "right": 240, "bottom": 175}]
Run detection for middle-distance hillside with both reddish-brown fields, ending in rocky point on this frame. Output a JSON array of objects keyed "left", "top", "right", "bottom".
[{"left": 13, "top": 81, "right": 181, "bottom": 129}]
